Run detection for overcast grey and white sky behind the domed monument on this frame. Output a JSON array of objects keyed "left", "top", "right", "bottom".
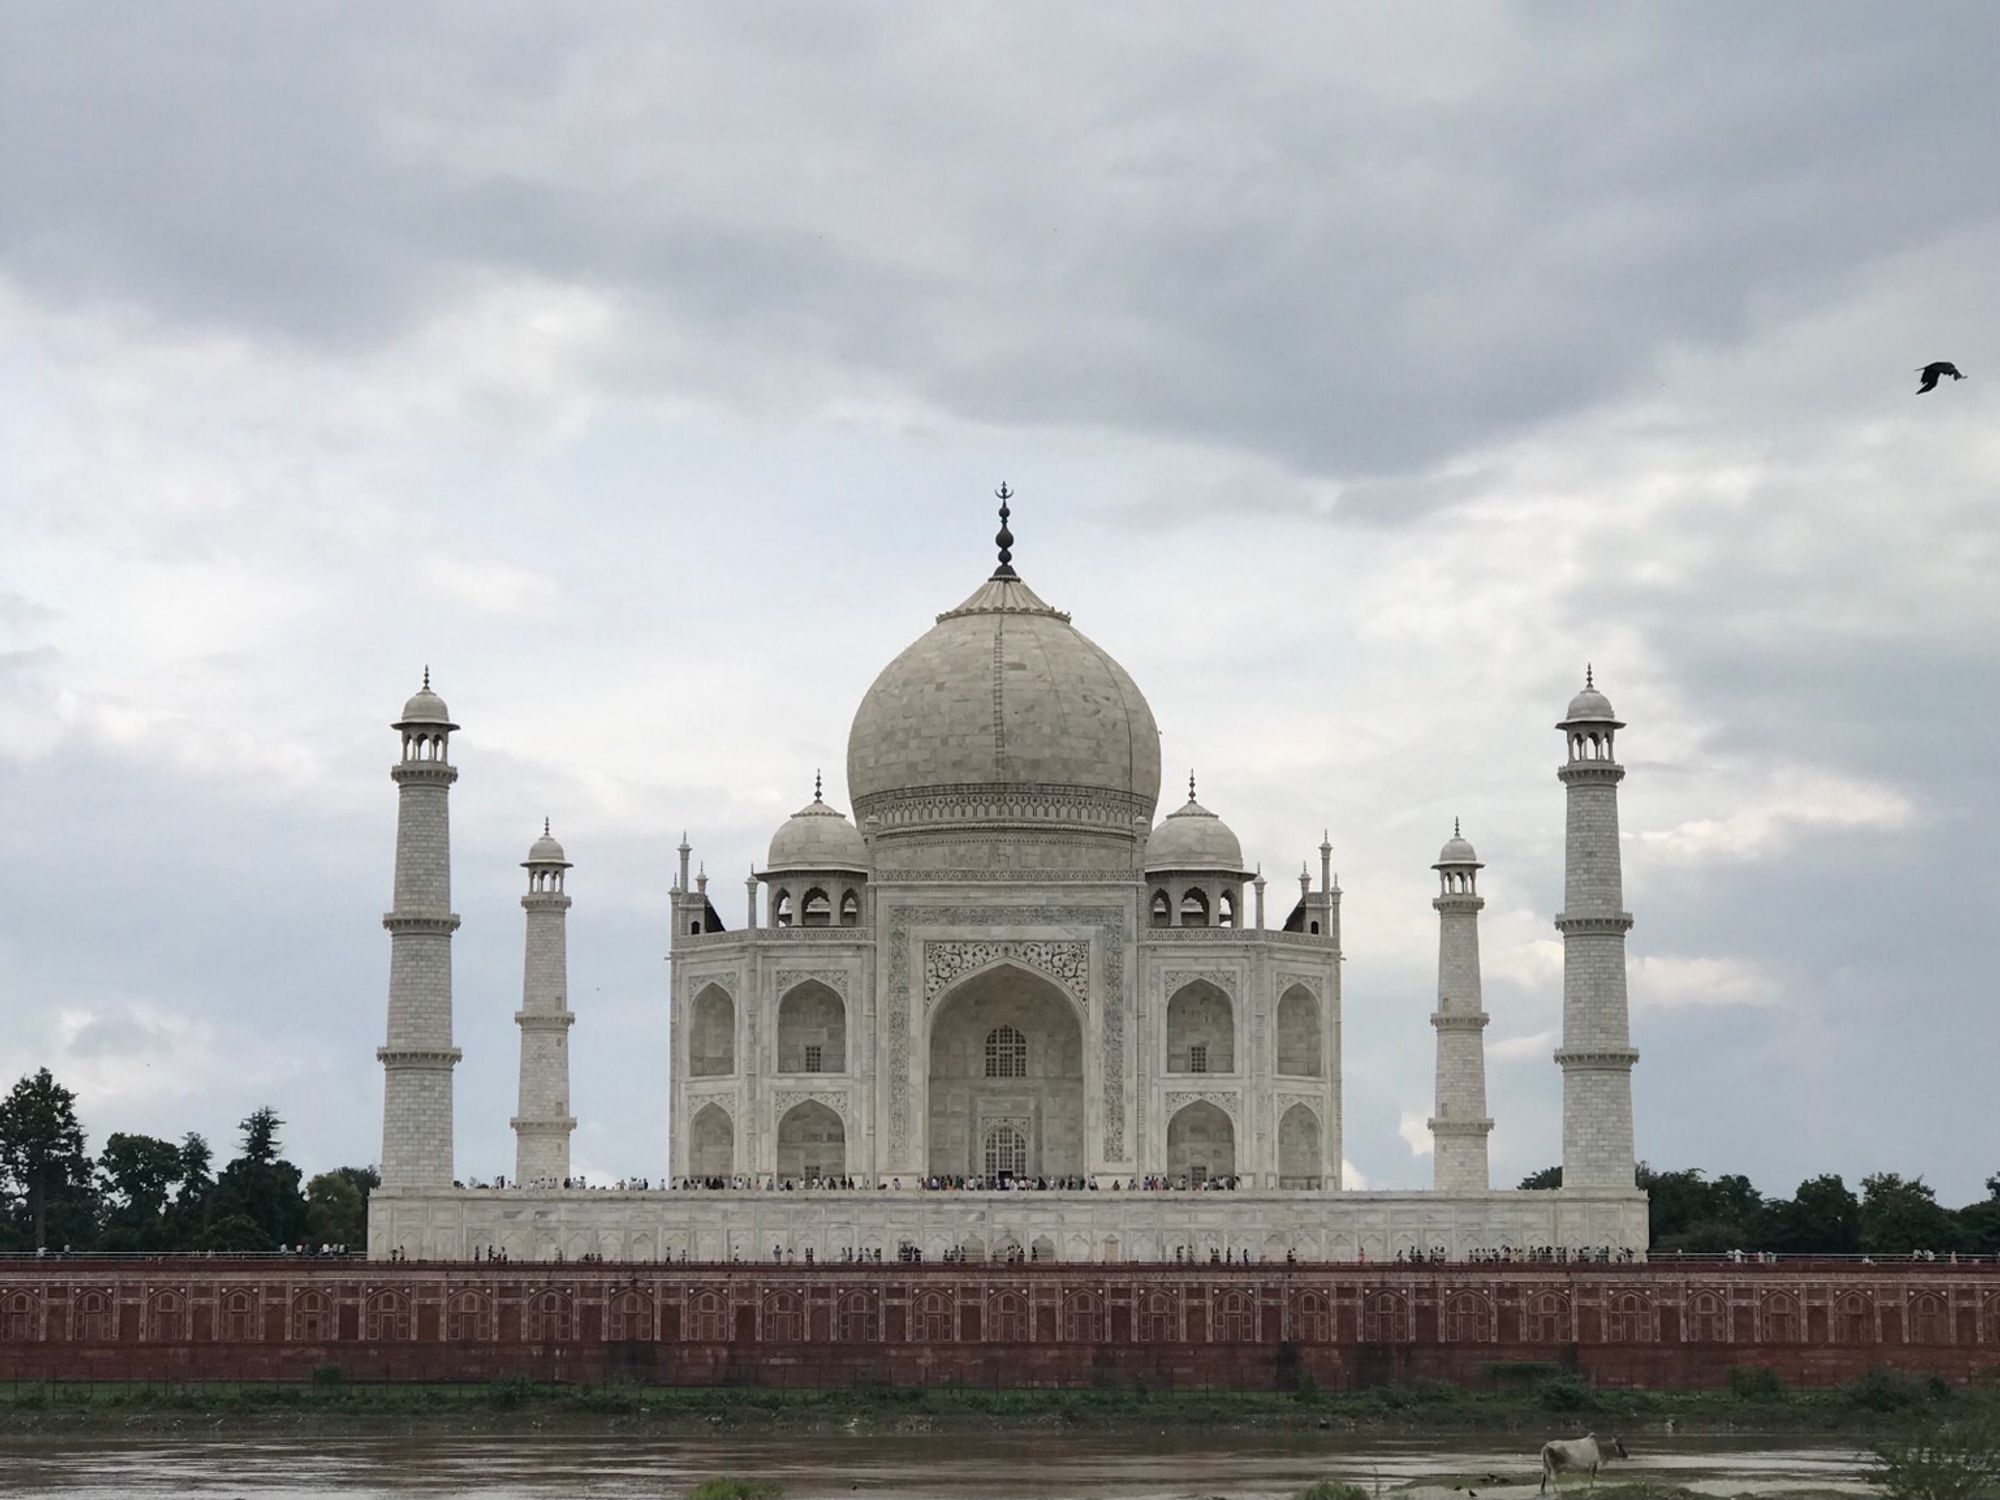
[{"left": 0, "top": 0, "right": 2000, "bottom": 1202}]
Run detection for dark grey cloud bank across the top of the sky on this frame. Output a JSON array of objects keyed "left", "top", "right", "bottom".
[{"left": 15, "top": 6, "right": 2000, "bottom": 488}]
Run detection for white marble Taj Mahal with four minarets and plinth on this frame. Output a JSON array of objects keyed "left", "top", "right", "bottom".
[{"left": 368, "top": 500, "right": 1646, "bottom": 1262}]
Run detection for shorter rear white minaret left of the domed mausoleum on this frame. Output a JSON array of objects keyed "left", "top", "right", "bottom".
[{"left": 512, "top": 818, "right": 576, "bottom": 1184}]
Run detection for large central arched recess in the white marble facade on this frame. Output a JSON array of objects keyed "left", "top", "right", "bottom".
[{"left": 926, "top": 964, "right": 1086, "bottom": 1176}]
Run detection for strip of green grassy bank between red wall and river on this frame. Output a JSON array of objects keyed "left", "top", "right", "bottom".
[{"left": 0, "top": 1368, "right": 2000, "bottom": 1440}]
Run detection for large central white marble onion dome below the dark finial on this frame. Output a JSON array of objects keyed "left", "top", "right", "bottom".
[{"left": 848, "top": 570, "right": 1160, "bottom": 838}]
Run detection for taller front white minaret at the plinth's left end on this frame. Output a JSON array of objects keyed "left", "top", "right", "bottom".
[{"left": 376, "top": 666, "right": 458, "bottom": 1188}]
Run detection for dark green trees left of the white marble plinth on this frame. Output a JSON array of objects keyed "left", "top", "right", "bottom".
[{"left": 0, "top": 1068, "right": 382, "bottom": 1252}]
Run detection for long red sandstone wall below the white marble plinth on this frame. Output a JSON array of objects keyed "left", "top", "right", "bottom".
[{"left": 0, "top": 1258, "right": 2000, "bottom": 1388}]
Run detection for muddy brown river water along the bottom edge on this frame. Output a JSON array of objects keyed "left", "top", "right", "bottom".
[{"left": 0, "top": 1432, "right": 1864, "bottom": 1500}]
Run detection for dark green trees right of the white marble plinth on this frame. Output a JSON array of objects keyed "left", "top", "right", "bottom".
[{"left": 1520, "top": 1162, "right": 2000, "bottom": 1256}]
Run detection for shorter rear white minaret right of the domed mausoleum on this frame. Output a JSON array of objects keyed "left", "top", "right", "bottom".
[{"left": 1430, "top": 818, "right": 1494, "bottom": 1192}]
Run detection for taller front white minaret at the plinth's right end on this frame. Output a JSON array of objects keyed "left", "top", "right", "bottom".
[{"left": 1556, "top": 670, "right": 1638, "bottom": 1192}]
